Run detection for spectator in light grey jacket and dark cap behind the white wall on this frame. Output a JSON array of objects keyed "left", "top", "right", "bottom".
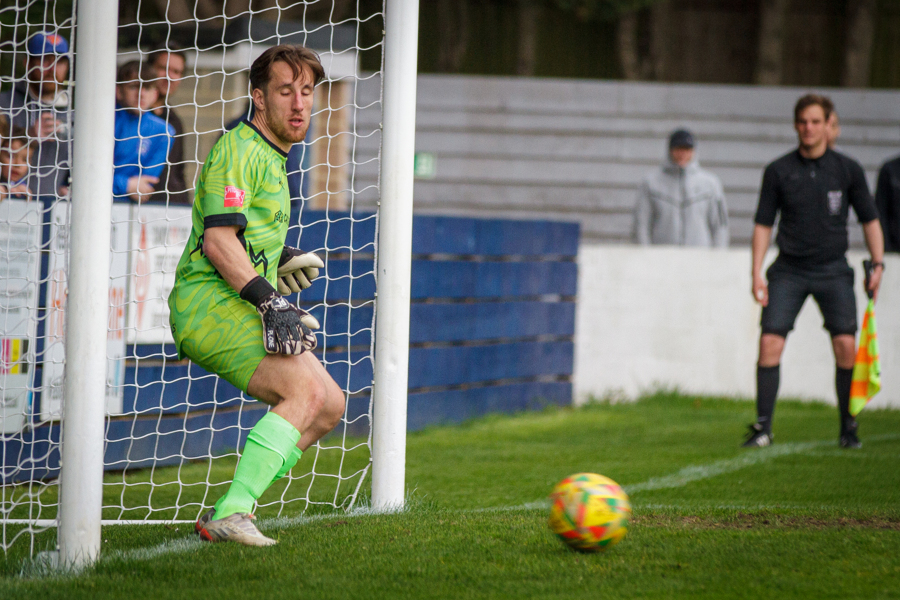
[{"left": 633, "top": 129, "right": 728, "bottom": 248}]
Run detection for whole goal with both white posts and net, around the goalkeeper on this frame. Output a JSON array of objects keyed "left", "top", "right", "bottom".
[{"left": 0, "top": 0, "right": 419, "bottom": 567}]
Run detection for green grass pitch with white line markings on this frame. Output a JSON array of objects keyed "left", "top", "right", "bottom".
[{"left": 0, "top": 392, "right": 900, "bottom": 600}]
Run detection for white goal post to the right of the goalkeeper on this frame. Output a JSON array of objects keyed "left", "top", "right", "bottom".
[{"left": 372, "top": 0, "right": 419, "bottom": 510}]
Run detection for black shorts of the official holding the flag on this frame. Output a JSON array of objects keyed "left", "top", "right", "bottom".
[{"left": 760, "top": 257, "right": 857, "bottom": 337}]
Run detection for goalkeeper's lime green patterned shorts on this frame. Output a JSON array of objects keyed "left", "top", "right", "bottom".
[{"left": 169, "top": 286, "right": 266, "bottom": 393}]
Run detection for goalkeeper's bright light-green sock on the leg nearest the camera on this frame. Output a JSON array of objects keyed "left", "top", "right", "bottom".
[{"left": 215, "top": 412, "right": 300, "bottom": 520}]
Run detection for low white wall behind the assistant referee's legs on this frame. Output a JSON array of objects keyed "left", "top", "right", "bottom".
[{"left": 575, "top": 244, "right": 900, "bottom": 408}]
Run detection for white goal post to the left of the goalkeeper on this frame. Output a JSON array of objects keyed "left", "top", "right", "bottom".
[{"left": 58, "top": 0, "right": 119, "bottom": 566}]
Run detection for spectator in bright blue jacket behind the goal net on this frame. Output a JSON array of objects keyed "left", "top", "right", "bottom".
[{"left": 113, "top": 60, "right": 175, "bottom": 202}]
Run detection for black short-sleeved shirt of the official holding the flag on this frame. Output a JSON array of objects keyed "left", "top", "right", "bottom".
[{"left": 755, "top": 150, "right": 878, "bottom": 264}]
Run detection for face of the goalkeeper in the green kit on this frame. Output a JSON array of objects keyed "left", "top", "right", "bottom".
[{"left": 256, "top": 61, "right": 315, "bottom": 146}]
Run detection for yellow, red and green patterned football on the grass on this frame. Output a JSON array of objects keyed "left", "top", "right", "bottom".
[{"left": 550, "top": 473, "right": 631, "bottom": 552}]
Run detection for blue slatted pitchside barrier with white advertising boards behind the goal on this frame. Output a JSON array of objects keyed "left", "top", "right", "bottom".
[{"left": 0, "top": 198, "right": 579, "bottom": 484}]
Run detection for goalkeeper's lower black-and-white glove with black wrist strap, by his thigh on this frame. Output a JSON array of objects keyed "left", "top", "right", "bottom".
[{"left": 241, "top": 277, "right": 319, "bottom": 354}]
